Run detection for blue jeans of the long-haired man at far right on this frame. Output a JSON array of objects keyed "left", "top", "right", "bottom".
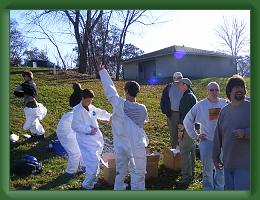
[{"left": 225, "top": 168, "right": 250, "bottom": 190}]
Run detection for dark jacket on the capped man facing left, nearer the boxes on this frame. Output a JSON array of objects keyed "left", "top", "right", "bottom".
[{"left": 179, "top": 88, "right": 197, "bottom": 124}]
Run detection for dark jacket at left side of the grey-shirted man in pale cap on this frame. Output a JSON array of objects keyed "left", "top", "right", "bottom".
[{"left": 160, "top": 83, "right": 172, "bottom": 117}]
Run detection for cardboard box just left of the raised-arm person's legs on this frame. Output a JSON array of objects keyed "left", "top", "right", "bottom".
[{"left": 101, "top": 153, "right": 116, "bottom": 185}]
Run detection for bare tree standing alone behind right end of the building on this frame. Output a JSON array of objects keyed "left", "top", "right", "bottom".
[{"left": 216, "top": 17, "right": 250, "bottom": 72}]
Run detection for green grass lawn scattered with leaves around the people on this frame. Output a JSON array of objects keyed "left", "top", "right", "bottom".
[{"left": 10, "top": 69, "right": 250, "bottom": 190}]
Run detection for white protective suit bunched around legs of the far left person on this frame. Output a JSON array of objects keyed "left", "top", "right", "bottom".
[{"left": 23, "top": 103, "right": 47, "bottom": 135}]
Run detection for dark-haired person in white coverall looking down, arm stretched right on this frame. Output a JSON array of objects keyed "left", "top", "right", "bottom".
[{"left": 71, "top": 89, "right": 111, "bottom": 190}]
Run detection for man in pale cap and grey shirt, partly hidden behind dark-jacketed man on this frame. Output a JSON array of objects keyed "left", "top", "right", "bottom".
[{"left": 160, "top": 72, "right": 183, "bottom": 149}]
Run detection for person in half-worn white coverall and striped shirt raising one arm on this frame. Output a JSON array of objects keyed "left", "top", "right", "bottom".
[{"left": 99, "top": 64, "right": 148, "bottom": 190}]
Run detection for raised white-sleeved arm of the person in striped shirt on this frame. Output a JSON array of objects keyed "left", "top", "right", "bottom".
[{"left": 99, "top": 64, "right": 120, "bottom": 107}]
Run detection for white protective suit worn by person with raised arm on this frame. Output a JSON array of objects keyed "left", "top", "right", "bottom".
[{"left": 99, "top": 69, "right": 148, "bottom": 190}]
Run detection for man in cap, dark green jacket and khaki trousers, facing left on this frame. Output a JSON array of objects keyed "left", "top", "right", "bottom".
[{"left": 176, "top": 78, "right": 197, "bottom": 187}]
